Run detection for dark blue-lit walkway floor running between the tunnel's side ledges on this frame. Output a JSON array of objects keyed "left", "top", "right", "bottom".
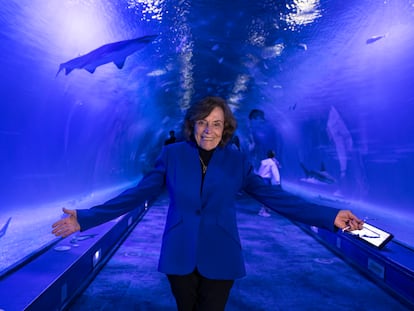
[{"left": 69, "top": 196, "right": 409, "bottom": 311}]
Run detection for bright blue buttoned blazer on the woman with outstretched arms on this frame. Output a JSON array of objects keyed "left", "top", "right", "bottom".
[{"left": 77, "top": 142, "right": 338, "bottom": 280}]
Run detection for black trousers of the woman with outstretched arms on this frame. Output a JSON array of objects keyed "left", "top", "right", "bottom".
[{"left": 167, "top": 270, "right": 234, "bottom": 311}]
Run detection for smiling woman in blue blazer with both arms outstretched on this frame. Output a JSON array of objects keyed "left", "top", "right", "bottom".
[{"left": 53, "top": 97, "right": 362, "bottom": 311}]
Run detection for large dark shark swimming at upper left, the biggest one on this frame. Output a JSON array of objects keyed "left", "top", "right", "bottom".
[{"left": 56, "top": 35, "right": 158, "bottom": 76}]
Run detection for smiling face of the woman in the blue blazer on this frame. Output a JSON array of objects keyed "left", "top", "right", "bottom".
[{"left": 194, "top": 107, "right": 224, "bottom": 151}]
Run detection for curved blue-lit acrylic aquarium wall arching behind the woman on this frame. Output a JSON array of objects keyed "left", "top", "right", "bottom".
[{"left": 0, "top": 0, "right": 414, "bottom": 302}]
